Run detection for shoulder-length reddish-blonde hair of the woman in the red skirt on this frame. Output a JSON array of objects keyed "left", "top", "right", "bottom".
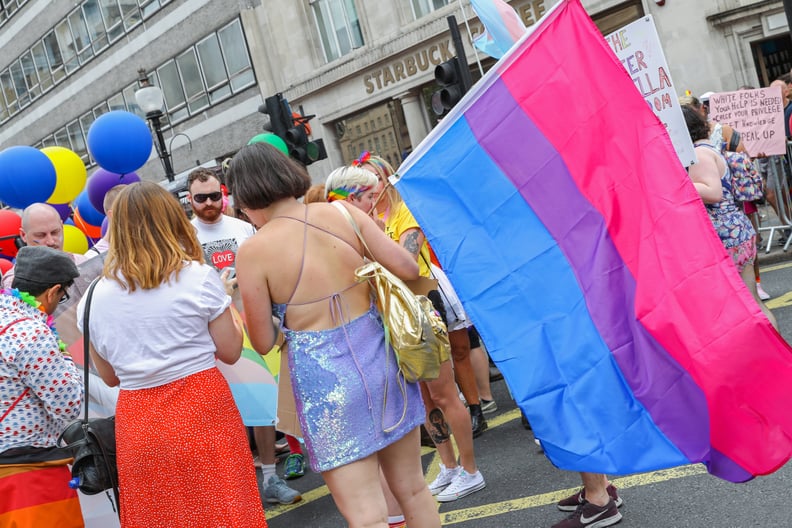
[{"left": 103, "top": 182, "right": 204, "bottom": 292}]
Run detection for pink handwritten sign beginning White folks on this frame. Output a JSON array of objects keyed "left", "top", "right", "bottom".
[{"left": 710, "top": 86, "right": 786, "bottom": 156}]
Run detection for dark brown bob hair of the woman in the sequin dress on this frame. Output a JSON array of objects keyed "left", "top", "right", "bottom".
[{"left": 228, "top": 143, "right": 311, "bottom": 209}]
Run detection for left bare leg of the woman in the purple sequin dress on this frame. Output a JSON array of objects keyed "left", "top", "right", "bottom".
[{"left": 322, "top": 454, "right": 390, "bottom": 528}]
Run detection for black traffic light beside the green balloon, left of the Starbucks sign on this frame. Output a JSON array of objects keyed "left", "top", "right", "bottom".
[{"left": 259, "top": 94, "right": 327, "bottom": 165}]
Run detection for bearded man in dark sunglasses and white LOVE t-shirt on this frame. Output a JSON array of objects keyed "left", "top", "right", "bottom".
[{"left": 187, "top": 168, "right": 302, "bottom": 504}]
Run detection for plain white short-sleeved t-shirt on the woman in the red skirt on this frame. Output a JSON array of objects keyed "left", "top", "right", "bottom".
[{"left": 77, "top": 262, "right": 231, "bottom": 390}]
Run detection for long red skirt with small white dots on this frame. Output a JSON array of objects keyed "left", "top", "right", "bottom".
[{"left": 116, "top": 368, "right": 267, "bottom": 528}]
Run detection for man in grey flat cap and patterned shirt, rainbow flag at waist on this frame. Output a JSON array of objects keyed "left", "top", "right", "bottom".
[{"left": 0, "top": 246, "right": 83, "bottom": 528}]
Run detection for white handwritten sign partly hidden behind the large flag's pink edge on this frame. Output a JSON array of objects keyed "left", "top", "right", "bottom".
[{"left": 605, "top": 15, "right": 696, "bottom": 167}]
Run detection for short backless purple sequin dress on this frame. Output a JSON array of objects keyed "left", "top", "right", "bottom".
[{"left": 283, "top": 307, "right": 424, "bottom": 472}]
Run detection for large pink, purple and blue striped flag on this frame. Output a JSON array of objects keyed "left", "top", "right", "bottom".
[{"left": 396, "top": 0, "right": 792, "bottom": 482}]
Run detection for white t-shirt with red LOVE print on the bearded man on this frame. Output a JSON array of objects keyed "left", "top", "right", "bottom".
[{"left": 191, "top": 215, "right": 256, "bottom": 271}]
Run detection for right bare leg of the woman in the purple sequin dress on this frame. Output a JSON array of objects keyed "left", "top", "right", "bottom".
[{"left": 377, "top": 428, "right": 442, "bottom": 528}]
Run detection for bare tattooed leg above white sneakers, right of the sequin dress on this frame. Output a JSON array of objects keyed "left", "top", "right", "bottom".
[{"left": 425, "top": 361, "right": 478, "bottom": 474}]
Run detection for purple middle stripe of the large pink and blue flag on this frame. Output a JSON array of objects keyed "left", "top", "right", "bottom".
[{"left": 465, "top": 80, "right": 710, "bottom": 461}]
